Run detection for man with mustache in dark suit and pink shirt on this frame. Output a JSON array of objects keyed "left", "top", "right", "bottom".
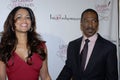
[{"left": 57, "top": 9, "right": 118, "bottom": 80}]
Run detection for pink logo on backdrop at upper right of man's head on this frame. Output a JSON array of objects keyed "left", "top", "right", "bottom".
[{"left": 95, "top": 0, "right": 111, "bottom": 21}]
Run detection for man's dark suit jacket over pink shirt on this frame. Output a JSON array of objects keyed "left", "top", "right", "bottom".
[{"left": 57, "top": 34, "right": 118, "bottom": 80}]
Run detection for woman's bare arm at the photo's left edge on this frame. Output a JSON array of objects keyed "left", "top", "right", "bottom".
[{"left": 0, "top": 61, "right": 6, "bottom": 80}]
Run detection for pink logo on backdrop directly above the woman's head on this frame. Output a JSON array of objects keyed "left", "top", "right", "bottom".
[{"left": 8, "top": 0, "right": 34, "bottom": 9}]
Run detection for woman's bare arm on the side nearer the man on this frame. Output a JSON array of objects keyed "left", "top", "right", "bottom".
[{"left": 40, "top": 45, "right": 51, "bottom": 80}]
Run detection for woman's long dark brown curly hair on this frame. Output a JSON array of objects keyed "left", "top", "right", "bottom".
[{"left": 0, "top": 6, "right": 46, "bottom": 63}]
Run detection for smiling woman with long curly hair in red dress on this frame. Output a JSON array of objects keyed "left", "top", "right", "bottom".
[{"left": 0, "top": 6, "right": 50, "bottom": 80}]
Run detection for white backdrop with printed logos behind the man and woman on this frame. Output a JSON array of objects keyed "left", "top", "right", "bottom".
[{"left": 0, "top": 0, "right": 118, "bottom": 80}]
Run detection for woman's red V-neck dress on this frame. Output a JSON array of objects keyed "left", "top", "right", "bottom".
[{"left": 6, "top": 52, "right": 42, "bottom": 80}]
